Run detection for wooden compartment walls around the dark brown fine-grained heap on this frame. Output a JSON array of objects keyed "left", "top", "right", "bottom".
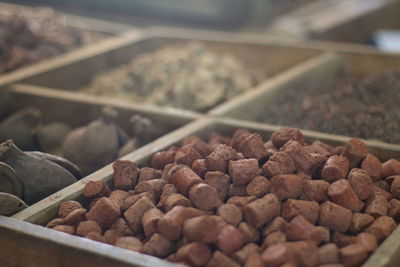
[{"left": 210, "top": 51, "right": 400, "bottom": 152}]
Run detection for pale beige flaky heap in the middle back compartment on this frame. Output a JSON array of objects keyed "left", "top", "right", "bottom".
[{"left": 83, "top": 42, "right": 259, "bottom": 111}]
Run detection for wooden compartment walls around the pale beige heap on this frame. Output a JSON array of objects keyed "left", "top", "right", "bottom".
[{"left": 13, "top": 29, "right": 320, "bottom": 113}]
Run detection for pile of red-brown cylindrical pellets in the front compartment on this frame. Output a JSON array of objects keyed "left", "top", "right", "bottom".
[{"left": 47, "top": 128, "right": 400, "bottom": 267}]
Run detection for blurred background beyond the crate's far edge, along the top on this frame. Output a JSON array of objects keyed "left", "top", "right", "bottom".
[{"left": 5, "top": 0, "right": 400, "bottom": 52}]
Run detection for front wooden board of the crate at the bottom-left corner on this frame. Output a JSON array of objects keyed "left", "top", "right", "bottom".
[{"left": 0, "top": 216, "right": 181, "bottom": 267}]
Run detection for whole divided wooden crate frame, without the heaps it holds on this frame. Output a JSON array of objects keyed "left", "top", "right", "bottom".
[{"left": 0, "top": 27, "right": 400, "bottom": 267}]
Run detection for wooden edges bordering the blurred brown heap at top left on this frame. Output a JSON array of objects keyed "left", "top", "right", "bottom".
[{"left": 0, "top": 2, "right": 134, "bottom": 87}]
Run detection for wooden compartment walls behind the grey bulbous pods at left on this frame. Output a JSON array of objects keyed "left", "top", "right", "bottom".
[{"left": 0, "top": 84, "right": 199, "bottom": 207}]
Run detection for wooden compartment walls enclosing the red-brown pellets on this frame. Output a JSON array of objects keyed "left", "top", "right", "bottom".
[{"left": 7, "top": 117, "right": 400, "bottom": 267}]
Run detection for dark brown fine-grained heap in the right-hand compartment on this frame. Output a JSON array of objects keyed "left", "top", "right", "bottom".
[{"left": 260, "top": 72, "right": 400, "bottom": 144}]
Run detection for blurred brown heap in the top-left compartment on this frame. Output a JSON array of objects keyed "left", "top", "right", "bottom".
[{"left": 0, "top": 6, "right": 105, "bottom": 73}]
